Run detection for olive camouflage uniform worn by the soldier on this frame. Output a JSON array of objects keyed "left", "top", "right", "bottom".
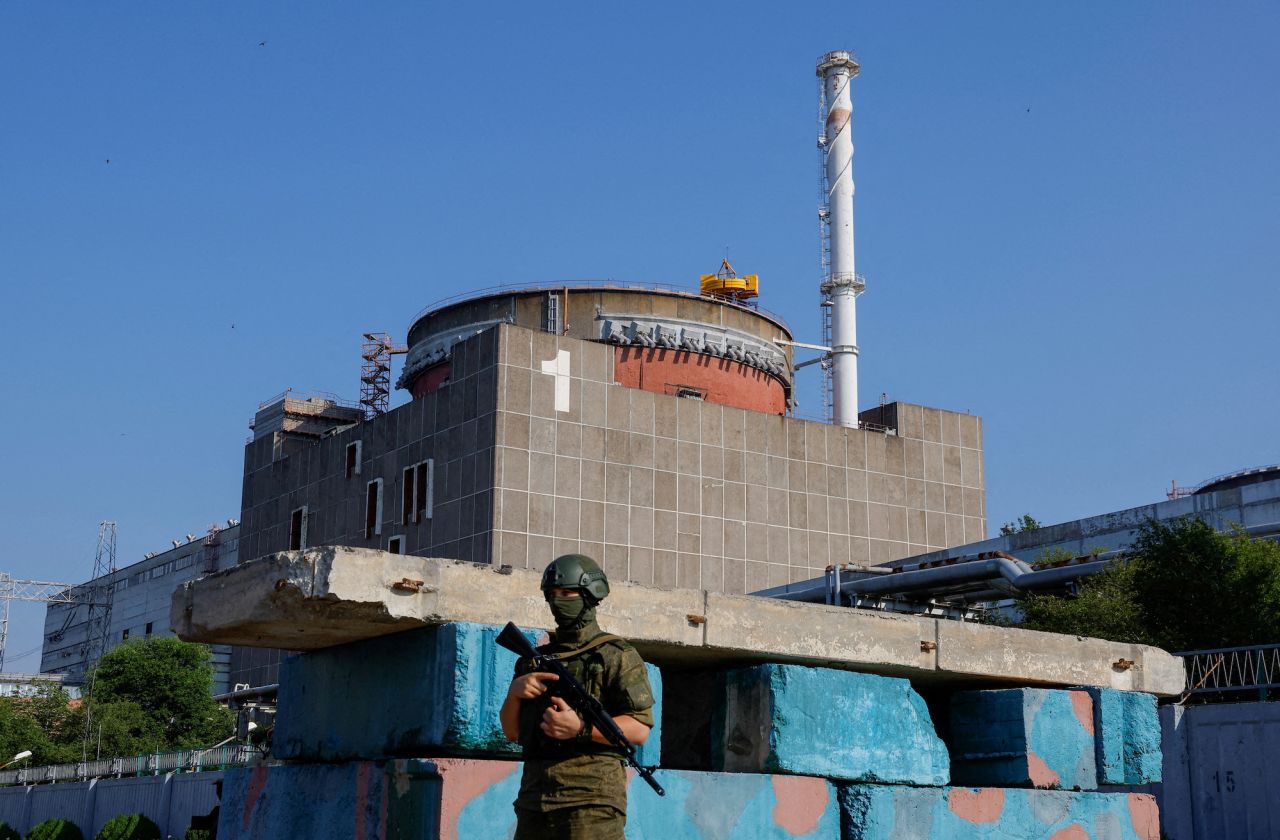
[{"left": 516, "top": 621, "right": 653, "bottom": 840}]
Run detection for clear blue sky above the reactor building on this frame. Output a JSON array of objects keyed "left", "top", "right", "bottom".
[{"left": 0, "top": 0, "right": 1280, "bottom": 668}]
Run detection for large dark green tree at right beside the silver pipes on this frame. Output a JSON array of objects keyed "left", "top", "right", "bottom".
[{"left": 1016, "top": 519, "right": 1280, "bottom": 650}]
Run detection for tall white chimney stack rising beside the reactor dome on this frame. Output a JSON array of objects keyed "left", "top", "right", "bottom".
[{"left": 817, "top": 50, "right": 865, "bottom": 428}]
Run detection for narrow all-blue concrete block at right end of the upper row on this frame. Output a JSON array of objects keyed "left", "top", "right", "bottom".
[{"left": 1085, "top": 688, "right": 1161, "bottom": 785}]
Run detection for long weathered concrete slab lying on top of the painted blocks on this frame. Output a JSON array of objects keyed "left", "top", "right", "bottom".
[{"left": 170, "top": 547, "right": 1185, "bottom": 697}]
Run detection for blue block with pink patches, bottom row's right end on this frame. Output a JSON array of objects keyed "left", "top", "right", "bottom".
[{"left": 839, "top": 785, "right": 1160, "bottom": 840}]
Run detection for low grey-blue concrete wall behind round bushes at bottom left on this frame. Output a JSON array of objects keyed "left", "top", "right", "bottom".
[{"left": 0, "top": 772, "right": 223, "bottom": 837}]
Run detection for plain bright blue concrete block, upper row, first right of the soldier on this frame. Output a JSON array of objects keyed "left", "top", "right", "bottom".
[{"left": 712, "top": 665, "right": 950, "bottom": 785}]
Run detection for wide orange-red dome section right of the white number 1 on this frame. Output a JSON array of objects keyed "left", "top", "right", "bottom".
[{"left": 613, "top": 347, "right": 787, "bottom": 415}]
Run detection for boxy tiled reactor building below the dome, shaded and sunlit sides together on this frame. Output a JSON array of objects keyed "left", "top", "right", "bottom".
[{"left": 241, "top": 323, "right": 986, "bottom": 593}]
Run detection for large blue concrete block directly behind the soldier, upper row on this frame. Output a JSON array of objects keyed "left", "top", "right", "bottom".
[{"left": 273, "top": 622, "right": 662, "bottom": 764}]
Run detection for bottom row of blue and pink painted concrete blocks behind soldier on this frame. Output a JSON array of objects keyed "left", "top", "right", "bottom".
[{"left": 218, "top": 759, "right": 1160, "bottom": 840}]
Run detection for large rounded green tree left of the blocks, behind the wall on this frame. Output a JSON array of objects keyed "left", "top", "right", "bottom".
[{"left": 87, "top": 636, "right": 236, "bottom": 755}]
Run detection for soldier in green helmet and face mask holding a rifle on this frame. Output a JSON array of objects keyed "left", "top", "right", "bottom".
[{"left": 502, "top": 554, "right": 653, "bottom": 840}]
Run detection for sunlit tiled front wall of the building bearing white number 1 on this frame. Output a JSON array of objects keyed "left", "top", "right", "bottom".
[{"left": 493, "top": 321, "right": 986, "bottom": 593}]
